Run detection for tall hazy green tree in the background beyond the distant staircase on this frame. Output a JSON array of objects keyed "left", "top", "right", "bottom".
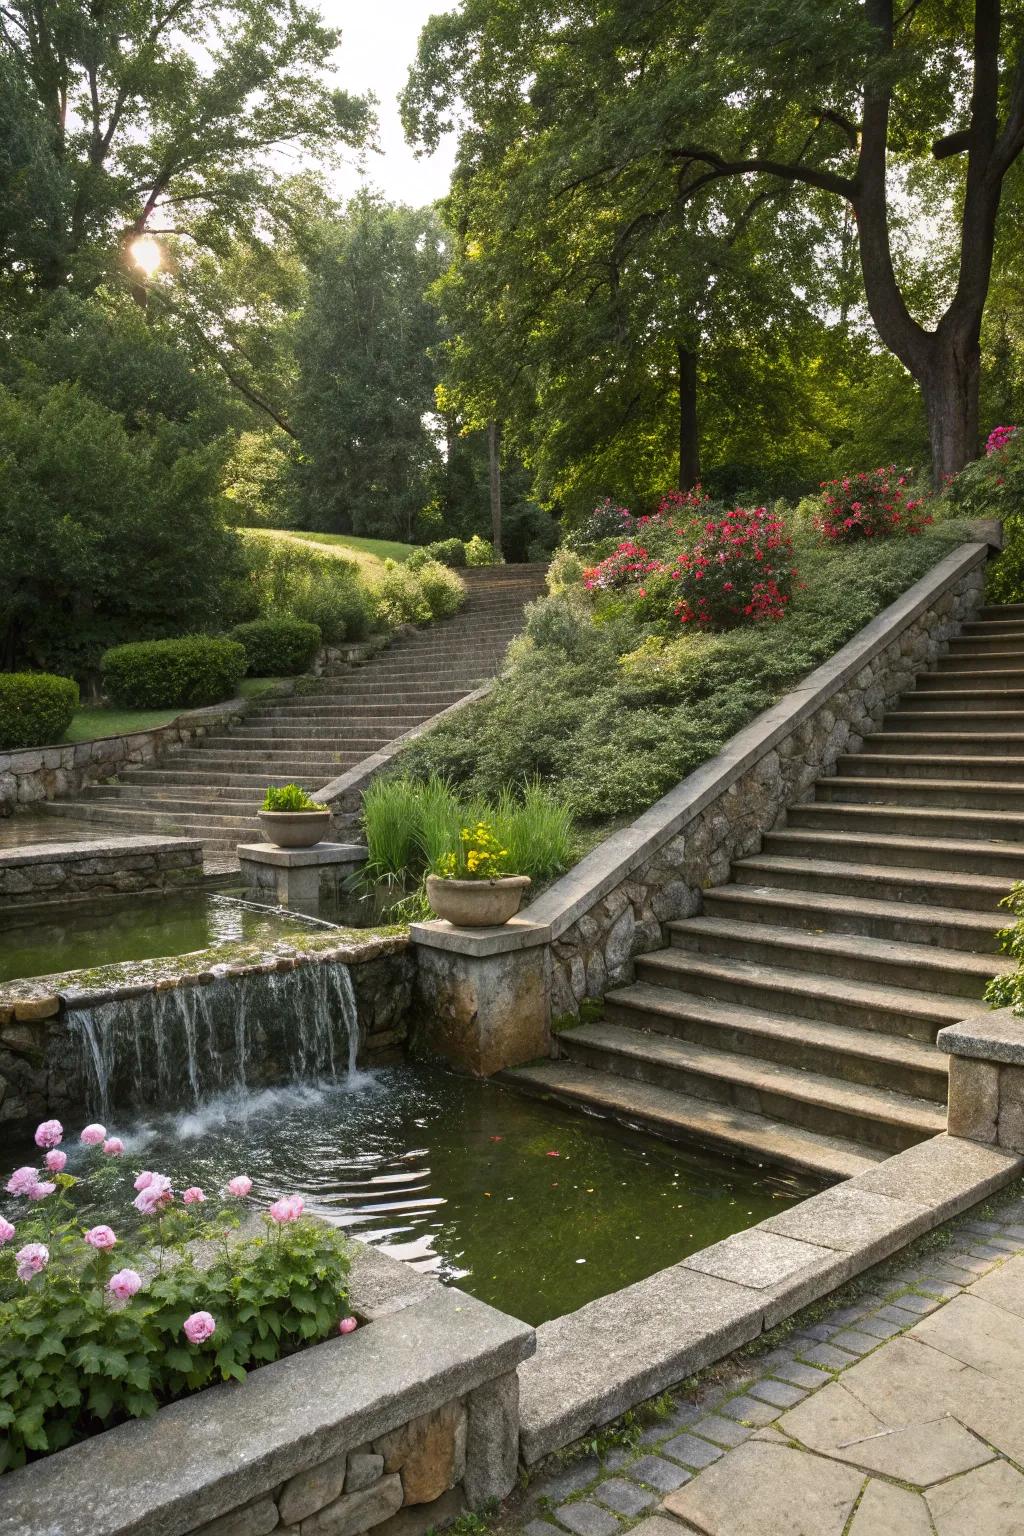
[{"left": 293, "top": 194, "right": 445, "bottom": 539}]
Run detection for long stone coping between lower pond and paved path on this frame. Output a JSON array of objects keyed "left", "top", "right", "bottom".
[{"left": 519, "top": 1135, "right": 1024, "bottom": 1465}]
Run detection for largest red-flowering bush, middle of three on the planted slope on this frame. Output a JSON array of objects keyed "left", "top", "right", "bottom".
[{"left": 669, "top": 507, "right": 797, "bottom": 628}]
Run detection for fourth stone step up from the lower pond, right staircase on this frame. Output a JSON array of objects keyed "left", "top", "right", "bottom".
[{"left": 636, "top": 948, "right": 964, "bottom": 1043}]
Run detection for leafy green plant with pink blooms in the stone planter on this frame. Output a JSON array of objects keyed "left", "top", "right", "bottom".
[{"left": 0, "top": 1120, "right": 356, "bottom": 1471}]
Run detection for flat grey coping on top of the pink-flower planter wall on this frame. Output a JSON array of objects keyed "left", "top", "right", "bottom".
[{"left": 0, "top": 1253, "right": 534, "bottom": 1536}]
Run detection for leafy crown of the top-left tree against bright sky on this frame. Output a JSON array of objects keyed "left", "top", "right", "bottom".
[{"left": 0, "top": 0, "right": 370, "bottom": 292}]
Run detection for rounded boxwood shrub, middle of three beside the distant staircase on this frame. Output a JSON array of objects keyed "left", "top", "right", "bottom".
[{"left": 100, "top": 634, "right": 249, "bottom": 710}]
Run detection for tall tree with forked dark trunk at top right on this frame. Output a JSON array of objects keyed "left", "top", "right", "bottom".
[{"left": 405, "top": 0, "right": 1024, "bottom": 479}]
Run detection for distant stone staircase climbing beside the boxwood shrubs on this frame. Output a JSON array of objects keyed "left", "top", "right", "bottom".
[{"left": 46, "top": 565, "right": 545, "bottom": 854}]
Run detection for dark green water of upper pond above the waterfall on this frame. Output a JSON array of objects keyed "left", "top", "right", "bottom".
[{"left": 0, "top": 891, "right": 322, "bottom": 982}]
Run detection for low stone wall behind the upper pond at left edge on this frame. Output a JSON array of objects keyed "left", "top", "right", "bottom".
[{"left": 0, "top": 837, "right": 203, "bottom": 912}]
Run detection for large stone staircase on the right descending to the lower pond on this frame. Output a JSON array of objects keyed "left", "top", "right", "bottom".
[{"left": 508, "top": 605, "right": 1024, "bottom": 1178}]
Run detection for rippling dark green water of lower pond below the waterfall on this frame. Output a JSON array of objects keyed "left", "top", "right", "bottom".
[{"left": 66, "top": 1066, "right": 809, "bottom": 1324}]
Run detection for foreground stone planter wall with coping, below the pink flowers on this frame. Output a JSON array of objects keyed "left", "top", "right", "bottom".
[{"left": 0, "top": 1243, "right": 534, "bottom": 1536}]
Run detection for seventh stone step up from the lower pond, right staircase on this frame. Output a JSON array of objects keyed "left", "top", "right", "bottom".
[{"left": 720, "top": 842, "right": 1009, "bottom": 909}]
